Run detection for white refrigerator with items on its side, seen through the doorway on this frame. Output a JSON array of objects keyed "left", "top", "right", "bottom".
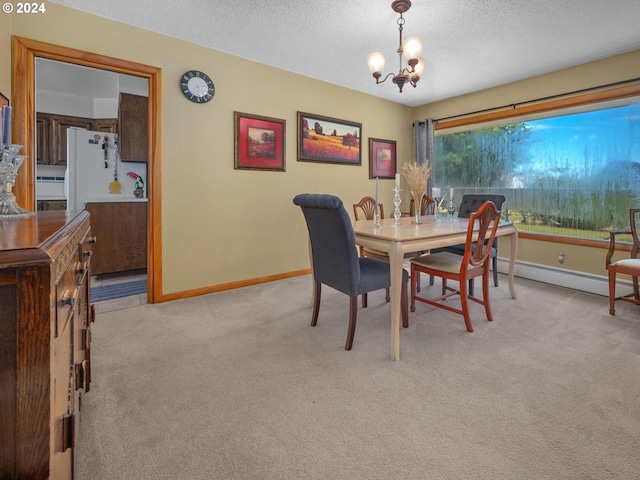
[{"left": 65, "top": 127, "right": 147, "bottom": 210}]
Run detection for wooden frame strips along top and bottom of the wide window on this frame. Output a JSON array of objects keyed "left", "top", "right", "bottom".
[{"left": 435, "top": 80, "right": 640, "bottom": 250}]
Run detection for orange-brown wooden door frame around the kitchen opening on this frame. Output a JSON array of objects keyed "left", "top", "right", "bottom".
[{"left": 12, "top": 36, "right": 162, "bottom": 303}]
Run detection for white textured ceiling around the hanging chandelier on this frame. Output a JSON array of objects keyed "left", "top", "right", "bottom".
[{"left": 50, "top": 0, "right": 640, "bottom": 106}]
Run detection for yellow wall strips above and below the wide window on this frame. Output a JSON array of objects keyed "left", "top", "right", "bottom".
[{"left": 413, "top": 50, "right": 640, "bottom": 275}]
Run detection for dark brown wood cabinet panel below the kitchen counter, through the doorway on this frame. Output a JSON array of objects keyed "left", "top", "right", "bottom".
[{"left": 86, "top": 202, "right": 148, "bottom": 275}]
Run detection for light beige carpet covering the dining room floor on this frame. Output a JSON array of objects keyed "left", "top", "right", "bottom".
[{"left": 76, "top": 276, "right": 640, "bottom": 480}]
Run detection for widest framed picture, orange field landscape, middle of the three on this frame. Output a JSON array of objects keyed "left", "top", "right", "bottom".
[{"left": 298, "top": 112, "right": 362, "bottom": 165}]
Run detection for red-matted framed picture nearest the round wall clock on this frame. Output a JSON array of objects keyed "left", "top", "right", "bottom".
[{"left": 234, "top": 112, "right": 286, "bottom": 172}]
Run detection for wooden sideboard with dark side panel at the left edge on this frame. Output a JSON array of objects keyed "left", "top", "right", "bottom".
[{"left": 0, "top": 210, "right": 95, "bottom": 480}]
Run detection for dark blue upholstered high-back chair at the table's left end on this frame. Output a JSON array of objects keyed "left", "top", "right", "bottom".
[{"left": 293, "top": 193, "right": 409, "bottom": 350}]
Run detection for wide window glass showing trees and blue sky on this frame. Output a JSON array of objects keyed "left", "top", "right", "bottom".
[{"left": 433, "top": 85, "right": 640, "bottom": 243}]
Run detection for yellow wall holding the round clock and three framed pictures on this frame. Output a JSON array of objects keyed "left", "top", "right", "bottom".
[{"left": 0, "top": 3, "right": 412, "bottom": 294}]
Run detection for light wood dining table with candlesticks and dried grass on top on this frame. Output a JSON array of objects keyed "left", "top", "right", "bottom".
[{"left": 353, "top": 215, "right": 518, "bottom": 361}]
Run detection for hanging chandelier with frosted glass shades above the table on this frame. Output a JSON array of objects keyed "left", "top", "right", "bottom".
[{"left": 367, "top": 0, "right": 424, "bottom": 93}]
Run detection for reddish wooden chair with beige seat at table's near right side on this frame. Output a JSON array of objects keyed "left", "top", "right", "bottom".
[{"left": 410, "top": 202, "right": 500, "bottom": 332}]
